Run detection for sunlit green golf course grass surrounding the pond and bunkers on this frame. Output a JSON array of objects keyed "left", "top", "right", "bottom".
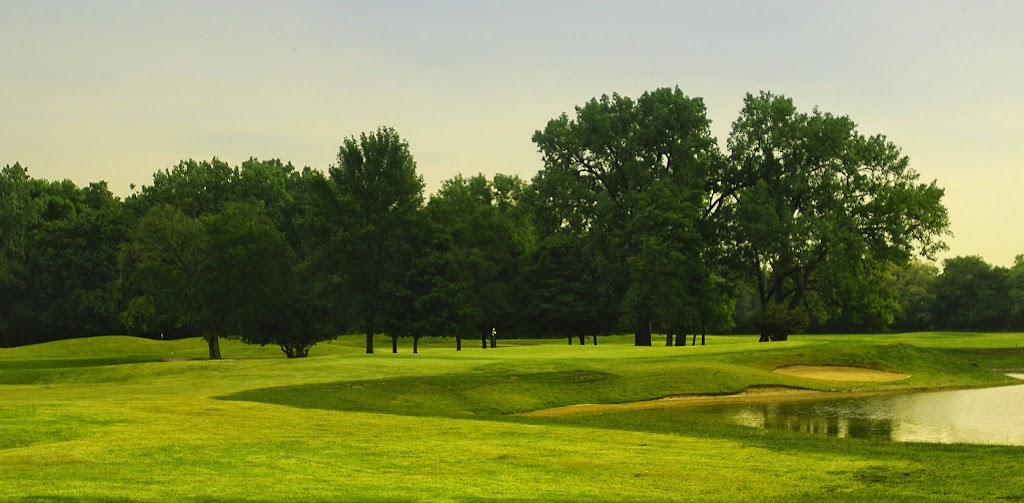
[{"left": 0, "top": 333, "right": 1024, "bottom": 501}]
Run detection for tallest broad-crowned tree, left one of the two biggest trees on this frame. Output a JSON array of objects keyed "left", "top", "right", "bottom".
[{"left": 534, "top": 88, "right": 722, "bottom": 345}]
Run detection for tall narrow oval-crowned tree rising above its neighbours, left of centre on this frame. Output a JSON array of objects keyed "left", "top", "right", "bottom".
[{"left": 326, "top": 127, "right": 424, "bottom": 353}]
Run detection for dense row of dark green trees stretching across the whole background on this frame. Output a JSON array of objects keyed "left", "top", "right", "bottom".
[{"left": 0, "top": 88, "right": 978, "bottom": 358}]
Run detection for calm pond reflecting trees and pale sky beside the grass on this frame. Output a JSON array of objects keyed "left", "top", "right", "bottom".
[{"left": 694, "top": 375, "right": 1024, "bottom": 446}]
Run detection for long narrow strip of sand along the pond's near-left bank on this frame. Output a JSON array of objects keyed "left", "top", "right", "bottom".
[{"left": 520, "top": 386, "right": 827, "bottom": 417}]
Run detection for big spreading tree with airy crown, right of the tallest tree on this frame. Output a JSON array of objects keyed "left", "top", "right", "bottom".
[{"left": 721, "top": 92, "right": 949, "bottom": 341}]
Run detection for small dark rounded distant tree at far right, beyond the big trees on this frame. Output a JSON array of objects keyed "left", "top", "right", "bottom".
[{"left": 933, "top": 255, "right": 1011, "bottom": 330}]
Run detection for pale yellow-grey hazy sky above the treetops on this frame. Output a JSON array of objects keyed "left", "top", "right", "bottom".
[{"left": 0, "top": 0, "right": 1024, "bottom": 265}]
